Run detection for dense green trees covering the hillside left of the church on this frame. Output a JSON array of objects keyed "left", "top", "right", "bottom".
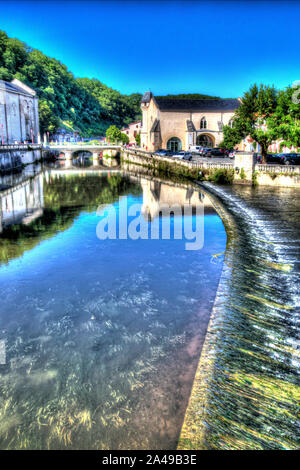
[{"left": 0, "top": 30, "right": 141, "bottom": 136}]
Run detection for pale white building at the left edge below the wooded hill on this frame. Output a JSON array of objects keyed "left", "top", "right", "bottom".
[{"left": 0, "top": 79, "right": 39, "bottom": 145}]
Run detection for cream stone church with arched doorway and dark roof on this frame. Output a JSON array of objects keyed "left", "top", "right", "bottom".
[{"left": 141, "top": 91, "right": 240, "bottom": 151}]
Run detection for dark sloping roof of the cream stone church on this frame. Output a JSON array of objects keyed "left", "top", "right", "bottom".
[{"left": 154, "top": 97, "right": 240, "bottom": 111}]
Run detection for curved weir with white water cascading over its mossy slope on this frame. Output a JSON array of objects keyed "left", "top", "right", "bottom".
[{"left": 180, "top": 184, "right": 300, "bottom": 449}]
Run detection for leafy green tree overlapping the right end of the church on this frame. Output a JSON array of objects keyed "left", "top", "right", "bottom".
[{"left": 223, "top": 84, "right": 278, "bottom": 157}]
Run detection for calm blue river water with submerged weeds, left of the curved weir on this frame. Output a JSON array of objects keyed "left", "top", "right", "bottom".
[{"left": 0, "top": 171, "right": 226, "bottom": 449}]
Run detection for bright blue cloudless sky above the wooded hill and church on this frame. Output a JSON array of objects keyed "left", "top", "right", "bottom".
[{"left": 0, "top": 0, "right": 300, "bottom": 98}]
